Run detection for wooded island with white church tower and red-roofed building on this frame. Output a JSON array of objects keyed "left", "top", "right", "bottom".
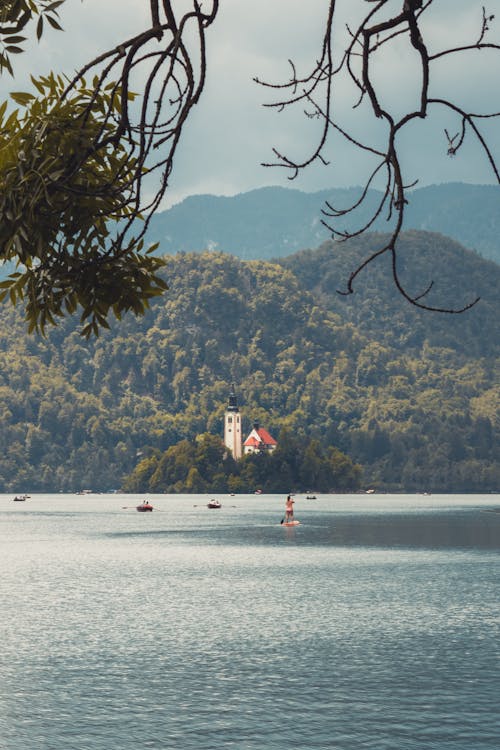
[{"left": 121, "top": 383, "right": 362, "bottom": 494}]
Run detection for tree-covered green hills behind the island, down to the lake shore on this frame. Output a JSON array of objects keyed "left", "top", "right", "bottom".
[{"left": 0, "top": 233, "right": 500, "bottom": 492}]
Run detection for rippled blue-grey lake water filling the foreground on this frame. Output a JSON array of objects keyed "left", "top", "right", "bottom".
[{"left": 0, "top": 495, "right": 500, "bottom": 750}]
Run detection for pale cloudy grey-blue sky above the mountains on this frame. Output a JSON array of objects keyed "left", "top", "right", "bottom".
[{"left": 0, "top": 0, "right": 500, "bottom": 208}]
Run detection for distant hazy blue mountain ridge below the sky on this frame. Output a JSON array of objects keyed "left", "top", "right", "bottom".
[{"left": 148, "top": 183, "right": 500, "bottom": 263}]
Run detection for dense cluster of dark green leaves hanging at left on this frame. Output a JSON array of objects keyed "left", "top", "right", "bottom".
[{"left": 0, "top": 75, "right": 167, "bottom": 337}]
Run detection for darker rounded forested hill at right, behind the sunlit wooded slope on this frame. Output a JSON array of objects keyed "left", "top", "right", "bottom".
[{"left": 280, "top": 232, "right": 500, "bottom": 358}]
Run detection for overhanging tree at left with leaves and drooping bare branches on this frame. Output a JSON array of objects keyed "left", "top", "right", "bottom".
[{"left": 0, "top": 0, "right": 218, "bottom": 337}]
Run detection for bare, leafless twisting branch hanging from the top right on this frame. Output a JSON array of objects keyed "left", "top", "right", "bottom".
[{"left": 255, "top": 0, "right": 500, "bottom": 313}]
